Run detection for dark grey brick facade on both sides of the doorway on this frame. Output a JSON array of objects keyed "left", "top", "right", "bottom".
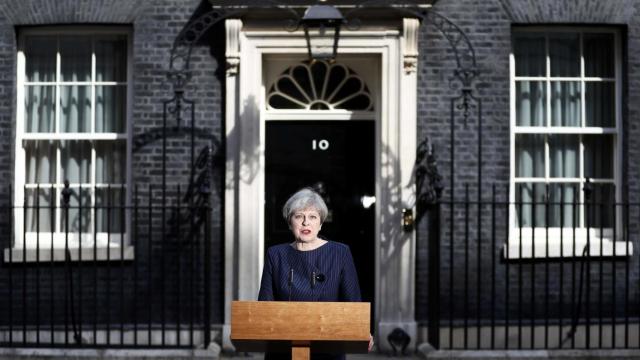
[{"left": 0, "top": 0, "right": 640, "bottom": 344}]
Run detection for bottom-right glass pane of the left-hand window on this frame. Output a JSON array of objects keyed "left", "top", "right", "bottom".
[{"left": 96, "top": 188, "right": 125, "bottom": 234}]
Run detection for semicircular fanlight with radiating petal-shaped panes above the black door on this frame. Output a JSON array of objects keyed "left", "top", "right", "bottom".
[{"left": 267, "top": 61, "right": 373, "bottom": 111}]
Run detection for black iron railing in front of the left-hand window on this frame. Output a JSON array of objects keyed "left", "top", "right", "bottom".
[{"left": 0, "top": 184, "right": 212, "bottom": 348}]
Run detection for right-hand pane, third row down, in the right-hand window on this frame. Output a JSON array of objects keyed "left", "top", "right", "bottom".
[{"left": 583, "top": 135, "right": 614, "bottom": 179}]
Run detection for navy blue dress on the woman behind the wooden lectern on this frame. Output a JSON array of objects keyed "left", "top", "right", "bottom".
[{"left": 258, "top": 241, "right": 361, "bottom": 360}]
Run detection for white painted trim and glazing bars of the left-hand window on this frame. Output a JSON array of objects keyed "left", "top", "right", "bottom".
[{"left": 9, "top": 26, "right": 133, "bottom": 261}]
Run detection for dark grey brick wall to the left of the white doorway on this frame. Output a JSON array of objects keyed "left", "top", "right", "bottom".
[{"left": 0, "top": 0, "right": 224, "bottom": 323}]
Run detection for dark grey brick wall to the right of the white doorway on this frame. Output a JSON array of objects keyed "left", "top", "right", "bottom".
[{"left": 416, "top": 0, "right": 640, "bottom": 324}]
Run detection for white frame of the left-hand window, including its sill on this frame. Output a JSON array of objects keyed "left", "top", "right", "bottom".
[{"left": 4, "top": 26, "right": 134, "bottom": 262}]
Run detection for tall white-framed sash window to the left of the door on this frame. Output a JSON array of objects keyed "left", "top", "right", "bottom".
[{"left": 10, "top": 29, "right": 130, "bottom": 258}]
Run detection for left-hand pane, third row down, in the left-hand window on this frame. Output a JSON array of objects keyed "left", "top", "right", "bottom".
[{"left": 23, "top": 140, "right": 57, "bottom": 184}]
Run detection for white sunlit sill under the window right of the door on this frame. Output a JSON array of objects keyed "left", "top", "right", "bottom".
[{"left": 503, "top": 238, "right": 633, "bottom": 260}]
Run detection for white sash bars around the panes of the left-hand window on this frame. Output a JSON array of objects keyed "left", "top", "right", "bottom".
[{"left": 14, "top": 28, "right": 132, "bottom": 247}]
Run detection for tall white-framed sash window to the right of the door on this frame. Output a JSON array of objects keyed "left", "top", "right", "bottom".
[{"left": 507, "top": 28, "right": 625, "bottom": 257}]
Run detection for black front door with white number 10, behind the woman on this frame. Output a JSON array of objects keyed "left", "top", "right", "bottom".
[{"left": 265, "top": 120, "right": 375, "bottom": 303}]
